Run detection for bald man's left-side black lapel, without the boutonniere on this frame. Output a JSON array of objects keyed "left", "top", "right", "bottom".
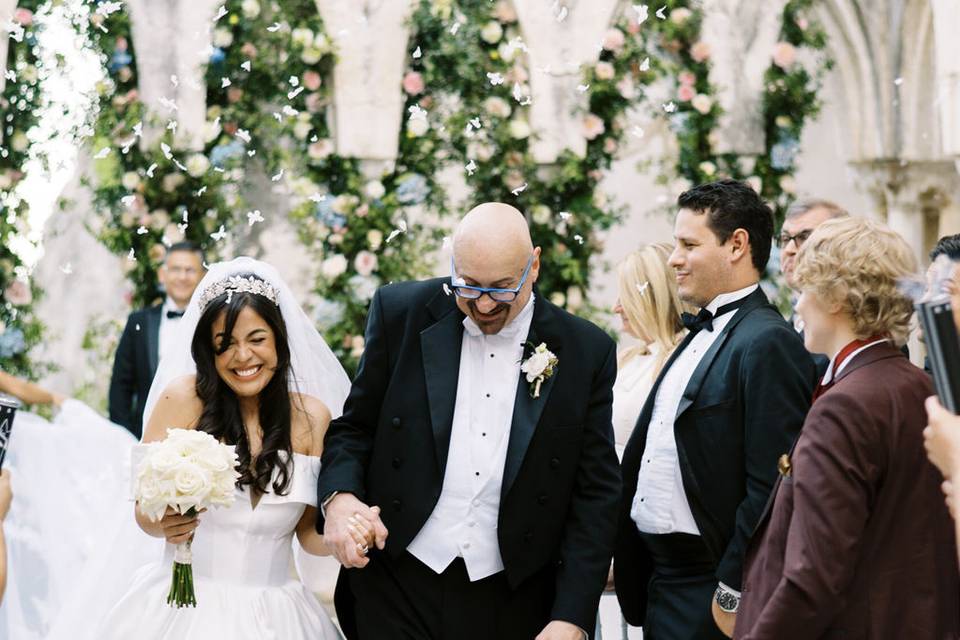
[{"left": 420, "top": 292, "right": 463, "bottom": 477}]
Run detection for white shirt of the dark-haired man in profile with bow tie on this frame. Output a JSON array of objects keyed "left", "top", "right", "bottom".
[{"left": 630, "top": 284, "right": 759, "bottom": 535}]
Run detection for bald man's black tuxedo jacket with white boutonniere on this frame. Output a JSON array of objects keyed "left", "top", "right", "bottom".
[{"left": 317, "top": 279, "right": 620, "bottom": 629}]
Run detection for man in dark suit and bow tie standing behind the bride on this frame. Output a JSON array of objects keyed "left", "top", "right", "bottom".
[{"left": 108, "top": 242, "right": 206, "bottom": 438}]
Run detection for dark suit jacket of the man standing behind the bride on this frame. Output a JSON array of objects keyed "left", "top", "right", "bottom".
[{"left": 108, "top": 305, "right": 163, "bottom": 438}]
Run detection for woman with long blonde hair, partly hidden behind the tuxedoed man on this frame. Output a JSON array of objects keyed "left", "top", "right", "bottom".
[{"left": 613, "top": 243, "right": 687, "bottom": 457}]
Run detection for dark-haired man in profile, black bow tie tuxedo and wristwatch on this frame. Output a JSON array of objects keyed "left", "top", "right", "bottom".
[{"left": 614, "top": 180, "right": 816, "bottom": 640}]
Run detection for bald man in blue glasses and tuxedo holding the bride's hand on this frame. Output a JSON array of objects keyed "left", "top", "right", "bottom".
[{"left": 317, "top": 203, "right": 620, "bottom": 640}]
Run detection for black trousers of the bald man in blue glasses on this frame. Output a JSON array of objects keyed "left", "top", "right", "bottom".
[{"left": 336, "top": 552, "right": 555, "bottom": 640}]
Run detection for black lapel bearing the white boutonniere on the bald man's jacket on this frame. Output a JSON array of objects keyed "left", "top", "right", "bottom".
[{"left": 500, "top": 295, "right": 564, "bottom": 500}]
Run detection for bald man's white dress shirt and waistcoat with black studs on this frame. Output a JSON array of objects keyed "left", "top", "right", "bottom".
[{"left": 407, "top": 295, "right": 533, "bottom": 582}]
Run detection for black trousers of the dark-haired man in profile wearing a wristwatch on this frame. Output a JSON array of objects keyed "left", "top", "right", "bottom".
[{"left": 641, "top": 533, "right": 726, "bottom": 640}]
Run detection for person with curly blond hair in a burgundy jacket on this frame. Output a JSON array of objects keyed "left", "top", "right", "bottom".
[{"left": 734, "top": 218, "right": 960, "bottom": 640}]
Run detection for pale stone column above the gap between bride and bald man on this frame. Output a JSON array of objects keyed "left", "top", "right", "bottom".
[{"left": 316, "top": 0, "right": 413, "bottom": 160}]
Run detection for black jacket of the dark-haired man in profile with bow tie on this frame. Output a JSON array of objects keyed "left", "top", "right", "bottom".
[{"left": 613, "top": 289, "right": 816, "bottom": 626}]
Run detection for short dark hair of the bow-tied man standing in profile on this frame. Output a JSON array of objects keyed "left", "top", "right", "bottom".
[{"left": 677, "top": 180, "right": 773, "bottom": 273}]
